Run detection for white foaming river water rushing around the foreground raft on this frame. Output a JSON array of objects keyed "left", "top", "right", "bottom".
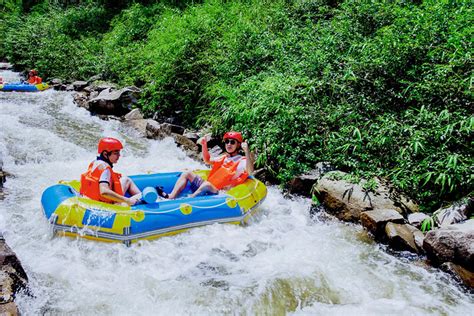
[{"left": 0, "top": 71, "right": 474, "bottom": 315}]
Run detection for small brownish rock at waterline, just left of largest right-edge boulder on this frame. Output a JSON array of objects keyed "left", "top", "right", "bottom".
[{"left": 385, "top": 223, "right": 423, "bottom": 253}]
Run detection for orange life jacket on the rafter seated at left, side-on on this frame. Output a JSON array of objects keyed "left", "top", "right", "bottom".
[{"left": 81, "top": 161, "right": 123, "bottom": 203}]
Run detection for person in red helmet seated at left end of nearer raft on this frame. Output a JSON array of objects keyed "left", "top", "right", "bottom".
[{"left": 81, "top": 137, "right": 142, "bottom": 205}]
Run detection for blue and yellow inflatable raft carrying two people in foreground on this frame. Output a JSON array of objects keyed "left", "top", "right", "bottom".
[{"left": 41, "top": 170, "right": 267, "bottom": 246}]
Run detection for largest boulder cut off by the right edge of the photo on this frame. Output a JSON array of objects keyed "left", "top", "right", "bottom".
[{"left": 423, "top": 219, "right": 474, "bottom": 271}]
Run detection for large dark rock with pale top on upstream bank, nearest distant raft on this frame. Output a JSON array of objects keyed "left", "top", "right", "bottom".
[{"left": 88, "top": 87, "right": 140, "bottom": 116}]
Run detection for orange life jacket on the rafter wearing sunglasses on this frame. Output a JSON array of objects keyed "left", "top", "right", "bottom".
[{"left": 207, "top": 156, "right": 249, "bottom": 190}]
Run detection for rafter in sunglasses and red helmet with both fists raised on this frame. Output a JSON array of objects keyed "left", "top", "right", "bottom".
[{"left": 157, "top": 132, "right": 253, "bottom": 199}]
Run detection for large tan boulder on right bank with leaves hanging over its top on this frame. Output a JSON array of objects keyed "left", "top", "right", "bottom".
[{"left": 314, "top": 172, "right": 418, "bottom": 222}]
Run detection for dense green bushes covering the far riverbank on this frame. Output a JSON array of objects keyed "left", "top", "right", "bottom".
[{"left": 0, "top": 0, "right": 474, "bottom": 210}]
